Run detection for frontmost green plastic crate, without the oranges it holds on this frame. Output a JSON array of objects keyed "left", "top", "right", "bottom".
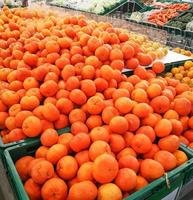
[{"left": 4, "top": 141, "right": 193, "bottom": 200}]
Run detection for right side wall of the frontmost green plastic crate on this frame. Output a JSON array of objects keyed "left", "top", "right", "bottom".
[{"left": 125, "top": 145, "right": 193, "bottom": 200}]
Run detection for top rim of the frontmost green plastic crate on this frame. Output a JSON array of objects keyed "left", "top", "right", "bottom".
[{"left": 4, "top": 141, "right": 193, "bottom": 200}]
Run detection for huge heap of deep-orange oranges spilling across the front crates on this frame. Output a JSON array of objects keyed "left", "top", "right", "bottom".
[{"left": 0, "top": 7, "right": 193, "bottom": 200}]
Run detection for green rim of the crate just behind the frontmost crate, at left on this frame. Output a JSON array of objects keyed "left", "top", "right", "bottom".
[{"left": 0, "top": 127, "right": 70, "bottom": 159}]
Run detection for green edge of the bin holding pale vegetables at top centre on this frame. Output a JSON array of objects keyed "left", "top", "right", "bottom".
[{"left": 46, "top": 0, "right": 128, "bottom": 15}]
